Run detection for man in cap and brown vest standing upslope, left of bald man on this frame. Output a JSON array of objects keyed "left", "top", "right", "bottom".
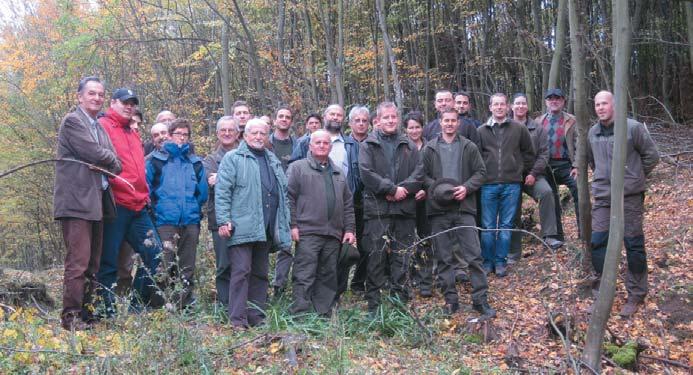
[{"left": 534, "top": 89, "right": 580, "bottom": 241}]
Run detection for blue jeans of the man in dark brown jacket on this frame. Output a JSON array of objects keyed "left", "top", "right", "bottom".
[{"left": 481, "top": 184, "right": 522, "bottom": 268}]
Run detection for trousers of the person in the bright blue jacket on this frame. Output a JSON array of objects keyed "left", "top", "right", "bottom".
[{"left": 158, "top": 224, "right": 200, "bottom": 308}]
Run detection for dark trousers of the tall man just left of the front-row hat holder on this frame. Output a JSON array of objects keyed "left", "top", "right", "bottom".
[{"left": 364, "top": 216, "right": 416, "bottom": 311}]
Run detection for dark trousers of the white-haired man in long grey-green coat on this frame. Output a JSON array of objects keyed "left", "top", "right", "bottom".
[{"left": 228, "top": 242, "right": 271, "bottom": 327}]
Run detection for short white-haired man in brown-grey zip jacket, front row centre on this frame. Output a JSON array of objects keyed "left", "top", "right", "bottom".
[{"left": 288, "top": 130, "right": 356, "bottom": 315}]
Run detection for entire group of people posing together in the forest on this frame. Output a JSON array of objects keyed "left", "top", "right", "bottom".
[{"left": 54, "top": 77, "right": 658, "bottom": 329}]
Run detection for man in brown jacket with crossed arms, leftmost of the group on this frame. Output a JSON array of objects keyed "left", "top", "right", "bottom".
[{"left": 53, "top": 77, "right": 121, "bottom": 330}]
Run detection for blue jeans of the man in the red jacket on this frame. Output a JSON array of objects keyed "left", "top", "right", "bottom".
[{"left": 96, "top": 205, "right": 162, "bottom": 316}]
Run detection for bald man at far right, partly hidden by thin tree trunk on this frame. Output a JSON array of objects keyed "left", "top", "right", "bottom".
[{"left": 587, "top": 91, "right": 659, "bottom": 318}]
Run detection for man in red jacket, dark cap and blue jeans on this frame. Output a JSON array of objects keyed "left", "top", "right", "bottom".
[{"left": 97, "top": 88, "right": 162, "bottom": 316}]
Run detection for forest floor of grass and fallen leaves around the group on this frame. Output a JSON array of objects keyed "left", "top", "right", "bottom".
[{"left": 0, "top": 155, "right": 693, "bottom": 374}]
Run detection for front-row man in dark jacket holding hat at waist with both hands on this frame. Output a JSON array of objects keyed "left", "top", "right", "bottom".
[{"left": 418, "top": 109, "right": 496, "bottom": 318}]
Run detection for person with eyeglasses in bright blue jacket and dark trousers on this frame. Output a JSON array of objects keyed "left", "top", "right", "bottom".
[{"left": 146, "top": 119, "right": 208, "bottom": 309}]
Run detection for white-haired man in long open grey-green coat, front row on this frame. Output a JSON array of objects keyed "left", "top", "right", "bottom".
[{"left": 214, "top": 119, "right": 291, "bottom": 328}]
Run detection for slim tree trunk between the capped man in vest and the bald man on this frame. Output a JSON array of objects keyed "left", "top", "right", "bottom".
[{"left": 568, "top": 0, "right": 592, "bottom": 271}]
